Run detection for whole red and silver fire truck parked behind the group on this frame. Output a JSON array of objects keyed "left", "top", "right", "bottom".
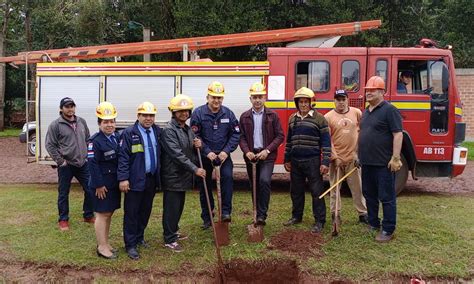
[{"left": 5, "top": 20, "right": 467, "bottom": 193}]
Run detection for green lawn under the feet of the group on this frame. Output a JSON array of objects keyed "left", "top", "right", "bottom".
[{"left": 0, "top": 185, "right": 474, "bottom": 281}]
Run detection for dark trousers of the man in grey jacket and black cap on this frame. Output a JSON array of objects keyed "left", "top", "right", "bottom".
[{"left": 58, "top": 163, "right": 94, "bottom": 221}]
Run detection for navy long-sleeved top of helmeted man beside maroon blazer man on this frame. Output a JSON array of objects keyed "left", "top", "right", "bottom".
[{"left": 191, "top": 104, "right": 240, "bottom": 156}]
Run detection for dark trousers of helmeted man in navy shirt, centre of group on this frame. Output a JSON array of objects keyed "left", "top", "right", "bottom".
[{"left": 199, "top": 156, "right": 234, "bottom": 222}]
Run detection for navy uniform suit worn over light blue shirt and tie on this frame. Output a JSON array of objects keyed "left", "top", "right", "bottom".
[{"left": 117, "top": 121, "right": 161, "bottom": 249}]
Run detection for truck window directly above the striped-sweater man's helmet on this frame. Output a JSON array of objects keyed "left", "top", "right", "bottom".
[{"left": 296, "top": 61, "right": 329, "bottom": 92}]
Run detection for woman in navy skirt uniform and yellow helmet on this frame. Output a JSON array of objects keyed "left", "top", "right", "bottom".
[{"left": 87, "top": 102, "right": 120, "bottom": 259}]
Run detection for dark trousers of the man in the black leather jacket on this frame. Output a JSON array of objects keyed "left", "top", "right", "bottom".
[{"left": 162, "top": 190, "right": 186, "bottom": 244}]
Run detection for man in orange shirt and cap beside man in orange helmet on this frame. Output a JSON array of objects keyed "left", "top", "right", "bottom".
[{"left": 324, "top": 90, "right": 367, "bottom": 234}]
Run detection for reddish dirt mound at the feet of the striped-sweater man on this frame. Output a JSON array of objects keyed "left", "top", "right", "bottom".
[{"left": 268, "top": 230, "right": 325, "bottom": 257}]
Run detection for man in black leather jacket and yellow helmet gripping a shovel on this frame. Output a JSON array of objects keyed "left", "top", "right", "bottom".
[{"left": 160, "top": 95, "right": 206, "bottom": 252}]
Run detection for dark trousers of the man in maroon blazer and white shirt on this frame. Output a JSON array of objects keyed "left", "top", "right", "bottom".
[{"left": 245, "top": 159, "right": 275, "bottom": 220}]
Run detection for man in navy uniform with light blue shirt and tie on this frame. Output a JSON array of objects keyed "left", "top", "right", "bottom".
[{"left": 117, "top": 102, "right": 161, "bottom": 260}]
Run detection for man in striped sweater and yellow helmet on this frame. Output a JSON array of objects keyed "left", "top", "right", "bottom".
[{"left": 284, "top": 87, "right": 331, "bottom": 233}]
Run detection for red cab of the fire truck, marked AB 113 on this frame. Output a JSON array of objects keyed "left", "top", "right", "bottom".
[{"left": 268, "top": 42, "right": 467, "bottom": 193}]
